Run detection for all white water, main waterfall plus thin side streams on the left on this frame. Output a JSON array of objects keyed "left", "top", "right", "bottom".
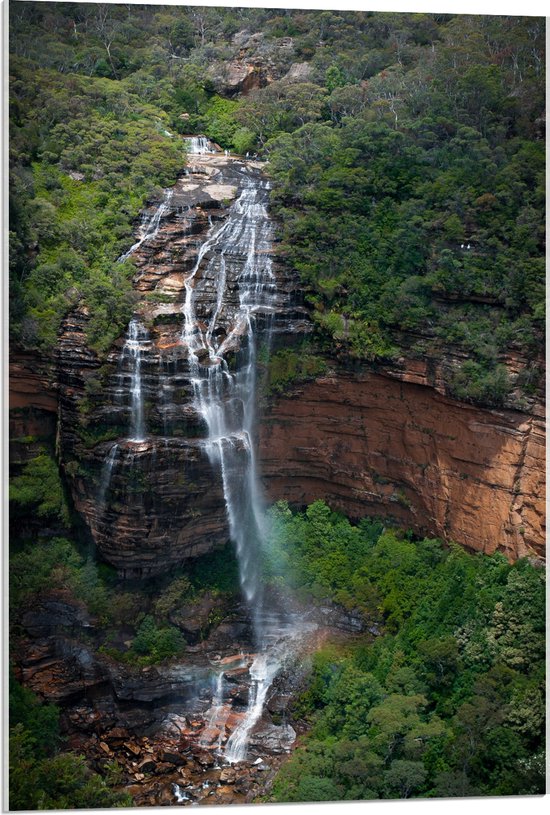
[{"left": 99, "top": 147, "right": 315, "bottom": 784}]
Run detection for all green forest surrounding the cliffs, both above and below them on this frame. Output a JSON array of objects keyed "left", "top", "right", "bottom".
[{"left": 9, "top": 0, "right": 545, "bottom": 809}]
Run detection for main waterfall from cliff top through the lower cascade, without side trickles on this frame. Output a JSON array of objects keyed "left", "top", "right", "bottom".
[{"left": 182, "top": 169, "right": 304, "bottom": 762}]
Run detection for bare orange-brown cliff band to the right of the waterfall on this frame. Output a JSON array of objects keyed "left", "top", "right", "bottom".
[{"left": 260, "top": 360, "right": 545, "bottom": 559}]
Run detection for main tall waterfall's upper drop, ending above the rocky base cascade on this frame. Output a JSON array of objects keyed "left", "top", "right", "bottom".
[{"left": 182, "top": 179, "right": 276, "bottom": 645}]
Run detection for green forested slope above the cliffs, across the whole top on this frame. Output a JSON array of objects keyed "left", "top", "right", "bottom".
[{"left": 10, "top": 2, "right": 545, "bottom": 404}]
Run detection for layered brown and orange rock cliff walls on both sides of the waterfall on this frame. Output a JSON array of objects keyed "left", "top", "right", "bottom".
[{"left": 10, "top": 155, "right": 544, "bottom": 577}]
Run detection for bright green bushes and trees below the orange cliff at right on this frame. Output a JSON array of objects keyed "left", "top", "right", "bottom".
[{"left": 270, "top": 501, "right": 545, "bottom": 802}]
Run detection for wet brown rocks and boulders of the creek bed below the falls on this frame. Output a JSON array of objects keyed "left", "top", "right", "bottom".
[{"left": 14, "top": 592, "right": 378, "bottom": 806}]
